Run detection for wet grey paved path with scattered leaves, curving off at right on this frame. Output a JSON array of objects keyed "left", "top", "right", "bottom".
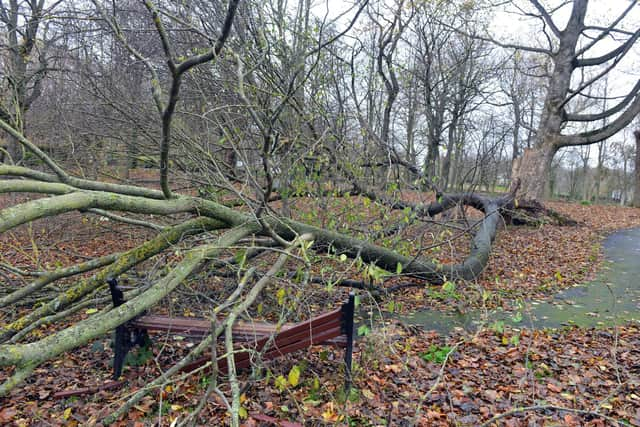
[{"left": 400, "top": 228, "right": 640, "bottom": 334}]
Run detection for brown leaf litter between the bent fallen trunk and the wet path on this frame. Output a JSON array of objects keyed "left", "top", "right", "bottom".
[{"left": 479, "top": 202, "right": 640, "bottom": 298}]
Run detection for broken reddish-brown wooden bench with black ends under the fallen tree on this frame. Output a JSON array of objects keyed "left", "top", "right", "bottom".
[{"left": 107, "top": 278, "right": 355, "bottom": 391}]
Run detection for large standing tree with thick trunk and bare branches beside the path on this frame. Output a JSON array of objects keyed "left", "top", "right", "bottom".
[{"left": 513, "top": 0, "right": 640, "bottom": 199}]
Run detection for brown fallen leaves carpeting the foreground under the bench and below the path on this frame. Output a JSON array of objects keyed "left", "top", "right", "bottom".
[{"left": 0, "top": 325, "right": 640, "bottom": 426}]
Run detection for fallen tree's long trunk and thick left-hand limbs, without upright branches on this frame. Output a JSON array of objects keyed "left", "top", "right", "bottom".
[{"left": 0, "top": 128, "right": 528, "bottom": 395}]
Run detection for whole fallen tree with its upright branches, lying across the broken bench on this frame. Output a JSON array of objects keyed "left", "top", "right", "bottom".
[{"left": 0, "top": 1, "right": 580, "bottom": 420}]
